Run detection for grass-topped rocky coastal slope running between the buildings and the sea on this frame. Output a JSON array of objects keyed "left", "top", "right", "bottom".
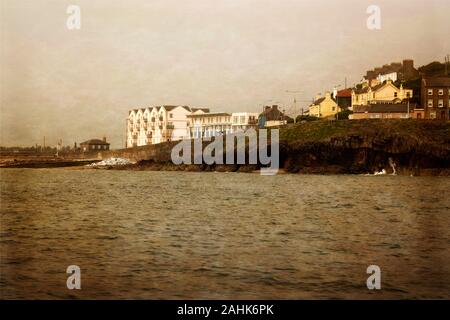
[{"left": 102, "top": 120, "right": 450, "bottom": 175}]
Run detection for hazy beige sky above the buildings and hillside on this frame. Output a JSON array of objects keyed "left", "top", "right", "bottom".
[{"left": 0, "top": 0, "right": 450, "bottom": 148}]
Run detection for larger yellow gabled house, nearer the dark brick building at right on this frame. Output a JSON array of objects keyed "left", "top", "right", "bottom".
[{"left": 352, "top": 80, "right": 413, "bottom": 106}]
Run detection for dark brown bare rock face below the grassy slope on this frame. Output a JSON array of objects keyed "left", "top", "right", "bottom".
[{"left": 281, "top": 134, "right": 450, "bottom": 175}]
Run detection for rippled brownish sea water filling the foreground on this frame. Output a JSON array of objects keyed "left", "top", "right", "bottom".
[{"left": 0, "top": 168, "right": 450, "bottom": 299}]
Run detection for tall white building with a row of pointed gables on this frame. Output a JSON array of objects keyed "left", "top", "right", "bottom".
[{"left": 126, "top": 106, "right": 209, "bottom": 148}]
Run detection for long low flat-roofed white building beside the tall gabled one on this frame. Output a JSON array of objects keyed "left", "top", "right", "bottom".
[{"left": 187, "top": 112, "right": 258, "bottom": 138}]
